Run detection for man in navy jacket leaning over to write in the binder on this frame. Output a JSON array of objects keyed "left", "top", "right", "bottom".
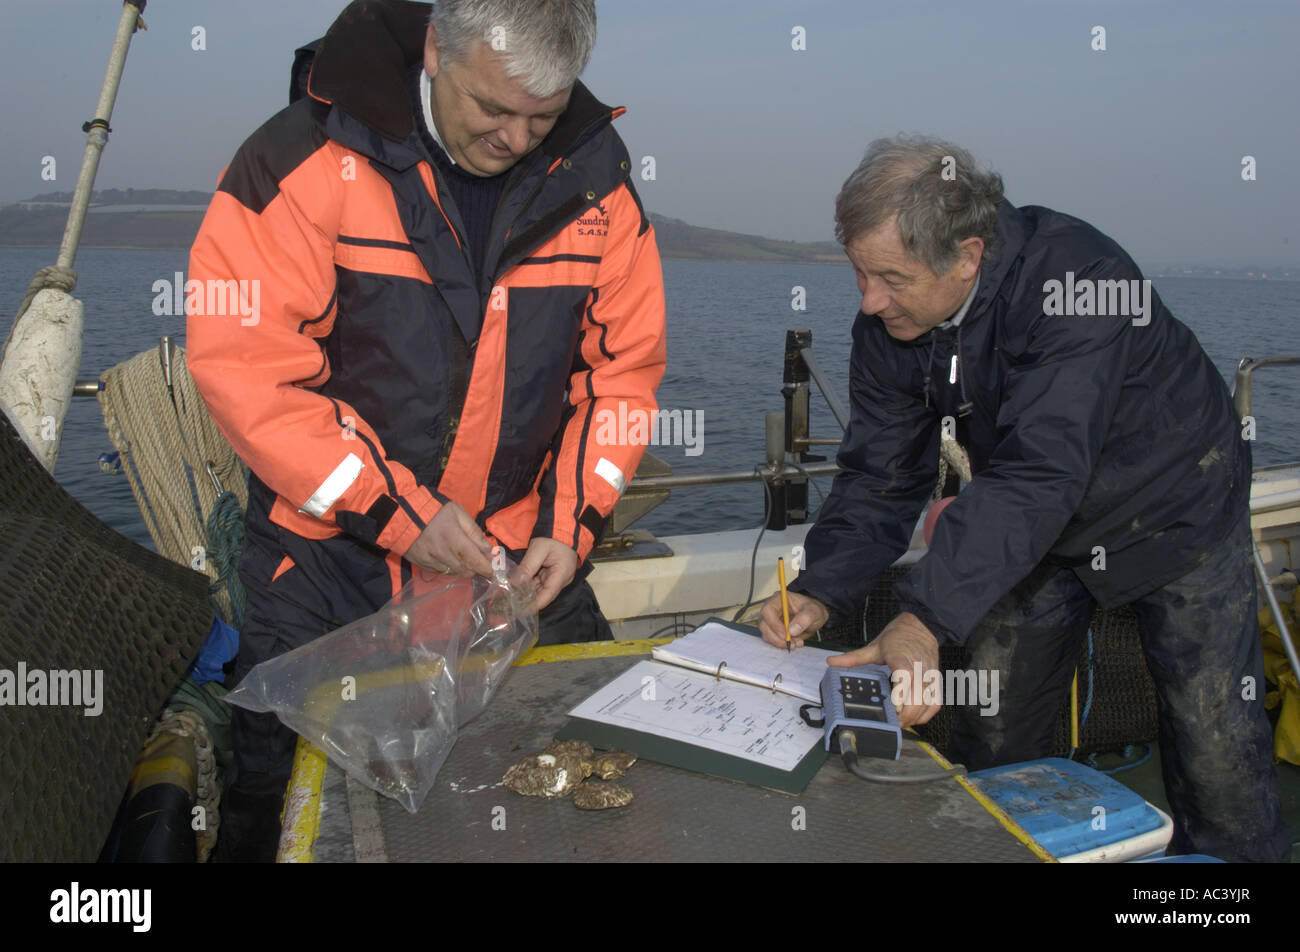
[{"left": 761, "top": 138, "right": 1290, "bottom": 861}]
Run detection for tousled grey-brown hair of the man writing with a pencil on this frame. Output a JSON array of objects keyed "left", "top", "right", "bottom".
[{"left": 835, "top": 135, "right": 1002, "bottom": 276}]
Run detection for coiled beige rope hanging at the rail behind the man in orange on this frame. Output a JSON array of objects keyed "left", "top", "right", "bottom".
[{"left": 99, "top": 345, "right": 248, "bottom": 628}]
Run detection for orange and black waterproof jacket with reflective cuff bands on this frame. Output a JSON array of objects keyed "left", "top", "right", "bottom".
[{"left": 186, "top": 0, "right": 664, "bottom": 587}]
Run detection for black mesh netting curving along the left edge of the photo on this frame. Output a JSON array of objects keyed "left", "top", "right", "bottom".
[{"left": 0, "top": 412, "right": 213, "bottom": 862}]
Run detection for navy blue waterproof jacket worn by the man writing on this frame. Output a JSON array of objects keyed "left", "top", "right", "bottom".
[{"left": 790, "top": 202, "right": 1251, "bottom": 644}]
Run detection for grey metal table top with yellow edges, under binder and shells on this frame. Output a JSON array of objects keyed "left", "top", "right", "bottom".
[{"left": 280, "top": 641, "right": 1049, "bottom": 862}]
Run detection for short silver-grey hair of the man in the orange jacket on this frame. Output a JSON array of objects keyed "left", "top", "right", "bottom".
[{"left": 429, "top": 0, "right": 595, "bottom": 99}]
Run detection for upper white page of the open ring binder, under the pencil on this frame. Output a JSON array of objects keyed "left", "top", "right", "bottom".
[{"left": 650, "top": 622, "right": 835, "bottom": 704}]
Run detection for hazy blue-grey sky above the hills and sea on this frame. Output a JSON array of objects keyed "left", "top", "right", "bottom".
[{"left": 0, "top": 0, "right": 1300, "bottom": 268}]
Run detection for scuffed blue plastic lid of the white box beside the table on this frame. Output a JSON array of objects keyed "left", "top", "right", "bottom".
[{"left": 970, "top": 757, "right": 1161, "bottom": 858}]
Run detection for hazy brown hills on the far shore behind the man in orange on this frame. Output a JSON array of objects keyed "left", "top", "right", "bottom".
[{"left": 0, "top": 189, "right": 844, "bottom": 261}]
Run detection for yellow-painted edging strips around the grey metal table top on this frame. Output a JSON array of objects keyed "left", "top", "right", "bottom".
[{"left": 276, "top": 639, "right": 1056, "bottom": 862}]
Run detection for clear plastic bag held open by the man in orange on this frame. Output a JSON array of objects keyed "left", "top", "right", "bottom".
[{"left": 225, "top": 549, "right": 537, "bottom": 813}]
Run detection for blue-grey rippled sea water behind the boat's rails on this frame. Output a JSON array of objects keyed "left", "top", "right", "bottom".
[{"left": 0, "top": 248, "right": 1300, "bottom": 548}]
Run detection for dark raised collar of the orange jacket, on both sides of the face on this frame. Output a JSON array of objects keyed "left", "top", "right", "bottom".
[{"left": 308, "top": 0, "right": 623, "bottom": 157}]
